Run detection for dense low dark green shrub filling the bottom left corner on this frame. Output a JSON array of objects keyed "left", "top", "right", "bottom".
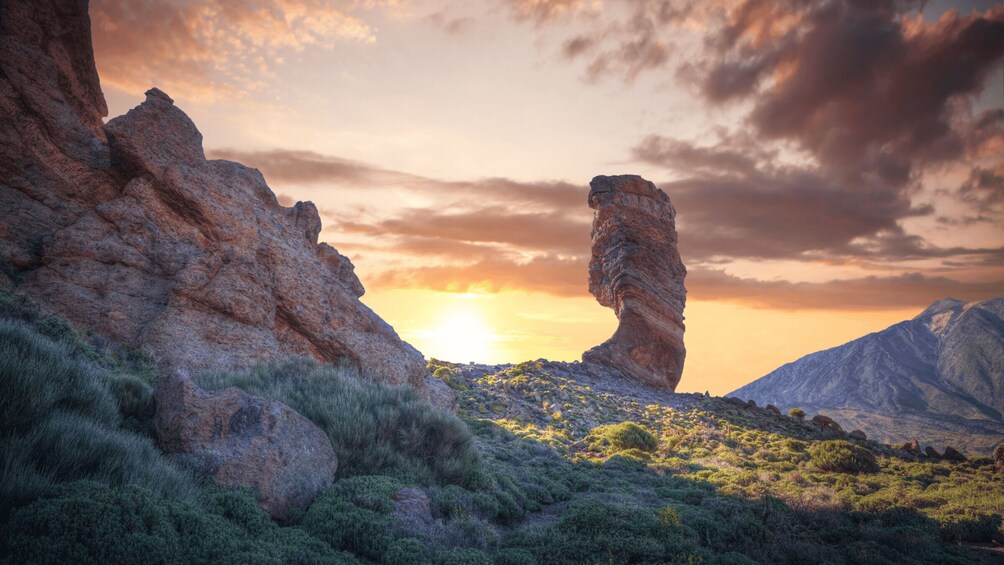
[{"left": 0, "top": 481, "right": 355, "bottom": 564}]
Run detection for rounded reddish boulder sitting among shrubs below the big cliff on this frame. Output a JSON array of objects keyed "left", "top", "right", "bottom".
[{"left": 155, "top": 373, "right": 338, "bottom": 520}]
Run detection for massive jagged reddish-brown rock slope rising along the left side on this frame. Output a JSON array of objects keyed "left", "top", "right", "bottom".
[{"left": 0, "top": 0, "right": 426, "bottom": 387}]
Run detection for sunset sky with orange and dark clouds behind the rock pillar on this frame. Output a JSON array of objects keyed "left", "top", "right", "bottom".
[{"left": 90, "top": 0, "right": 1004, "bottom": 394}]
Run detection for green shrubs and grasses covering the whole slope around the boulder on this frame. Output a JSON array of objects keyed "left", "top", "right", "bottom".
[{"left": 0, "top": 287, "right": 1004, "bottom": 564}]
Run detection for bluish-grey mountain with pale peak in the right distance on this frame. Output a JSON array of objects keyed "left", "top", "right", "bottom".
[{"left": 731, "top": 298, "right": 1004, "bottom": 452}]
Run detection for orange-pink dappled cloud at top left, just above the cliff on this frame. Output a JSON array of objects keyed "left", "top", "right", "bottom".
[{"left": 90, "top": 0, "right": 375, "bottom": 98}]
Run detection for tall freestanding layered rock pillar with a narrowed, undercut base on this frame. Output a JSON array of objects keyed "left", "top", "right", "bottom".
[{"left": 582, "top": 175, "right": 687, "bottom": 390}]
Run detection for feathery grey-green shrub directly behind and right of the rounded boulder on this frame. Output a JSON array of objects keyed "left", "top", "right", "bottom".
[{"left": 197, "top": 358, "right": 480, "bottom": 485}]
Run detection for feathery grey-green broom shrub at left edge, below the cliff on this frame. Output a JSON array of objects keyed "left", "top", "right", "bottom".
[{"left": 0, "top": 320, "right": 195, "bottom": 516}]
